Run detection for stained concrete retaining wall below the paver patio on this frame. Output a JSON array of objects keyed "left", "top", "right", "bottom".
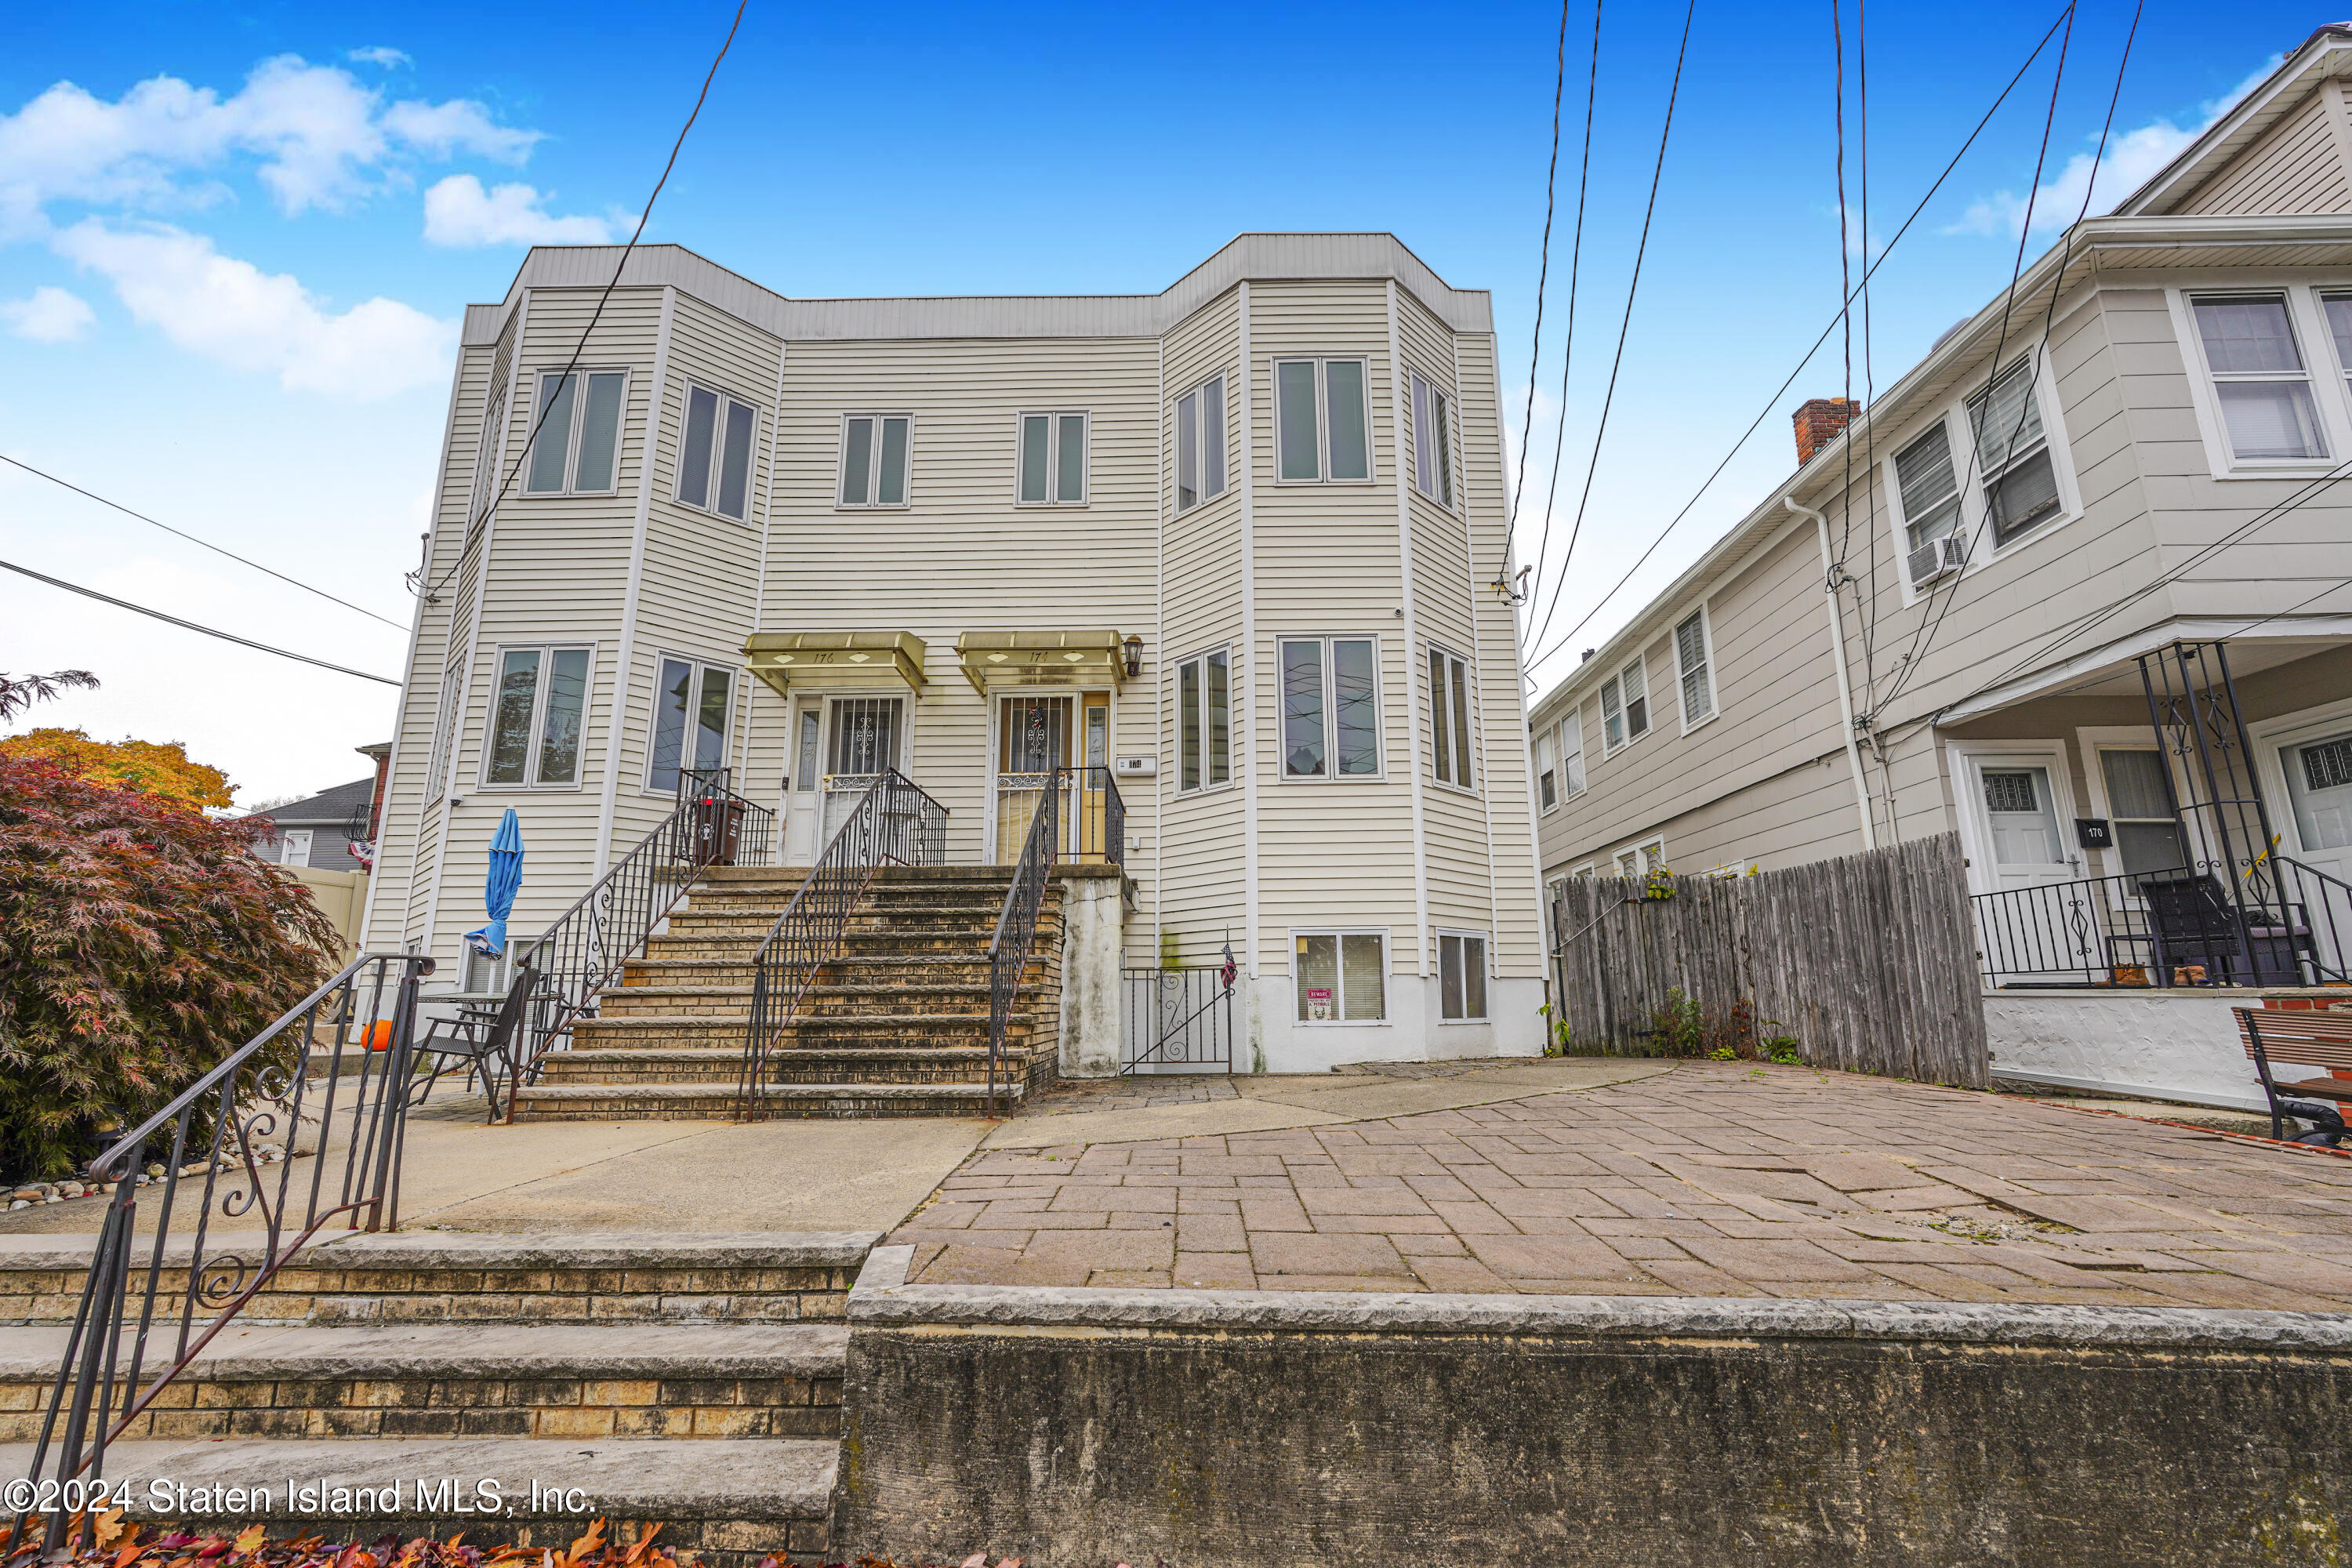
[{"left": 833, "top": 1248, "right": 2352, "bottom": 1568}]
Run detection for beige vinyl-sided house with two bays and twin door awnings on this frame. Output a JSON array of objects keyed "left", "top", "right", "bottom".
[{"left": 372, "top": 235, "right": 1543, "bottom": 1069}]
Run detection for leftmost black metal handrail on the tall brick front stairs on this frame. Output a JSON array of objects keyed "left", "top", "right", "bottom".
[{"left": 506, "top": 769, "right": 776, "bottom": 1121}]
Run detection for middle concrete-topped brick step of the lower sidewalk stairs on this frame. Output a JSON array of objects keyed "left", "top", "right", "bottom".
[{"left": 0, "top": 1319, "right": 849, "bottom": 1443}]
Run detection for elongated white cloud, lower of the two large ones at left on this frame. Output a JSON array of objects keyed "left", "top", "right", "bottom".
[{"left": 52, "top": 219, "right": 456, "bottom": 397}]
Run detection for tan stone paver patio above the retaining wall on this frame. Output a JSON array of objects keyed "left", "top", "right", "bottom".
[{"left": 891, "top": 1062, "right": 2352, "bottom": 1312}]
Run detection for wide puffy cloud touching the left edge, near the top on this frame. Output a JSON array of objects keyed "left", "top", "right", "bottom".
[{"left": 0, "top": 54, "right": 539, "bottom": 235}]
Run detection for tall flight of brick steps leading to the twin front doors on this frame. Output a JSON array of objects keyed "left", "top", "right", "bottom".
[{"left": 515, "top": 865, "right": 1061, "bottom": 1121}]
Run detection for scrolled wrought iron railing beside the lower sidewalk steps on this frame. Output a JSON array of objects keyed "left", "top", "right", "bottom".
[{"left": 12, "top": 952, "right": 433, "bottom": 1552}]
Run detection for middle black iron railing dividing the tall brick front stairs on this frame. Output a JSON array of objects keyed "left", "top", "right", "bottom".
[{"left": 736, "top": 769, "right": 948, "bottom": 1121}]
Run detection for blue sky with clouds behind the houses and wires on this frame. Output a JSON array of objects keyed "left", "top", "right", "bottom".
[{"left": 0, "top": 0, "right": 2326, "bottom": 801}]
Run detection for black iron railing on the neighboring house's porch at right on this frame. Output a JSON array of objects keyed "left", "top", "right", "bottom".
[{"left": 1969, "top": 853, "right": 2352, "bottom": 987}]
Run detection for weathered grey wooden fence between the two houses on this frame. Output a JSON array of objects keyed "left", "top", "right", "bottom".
[{"left": 1552, "top": 832, "right": 1987, "bottom": 1088}]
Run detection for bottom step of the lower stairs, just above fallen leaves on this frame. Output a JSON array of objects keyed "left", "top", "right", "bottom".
[{"left": 0, "top": 1439, "right": 840, "bottom": 1568}]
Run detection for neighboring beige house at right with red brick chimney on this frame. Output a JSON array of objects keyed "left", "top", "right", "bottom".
[{"left": 1529, "top": 28, "right": 2352, "bottom": 1100}]
